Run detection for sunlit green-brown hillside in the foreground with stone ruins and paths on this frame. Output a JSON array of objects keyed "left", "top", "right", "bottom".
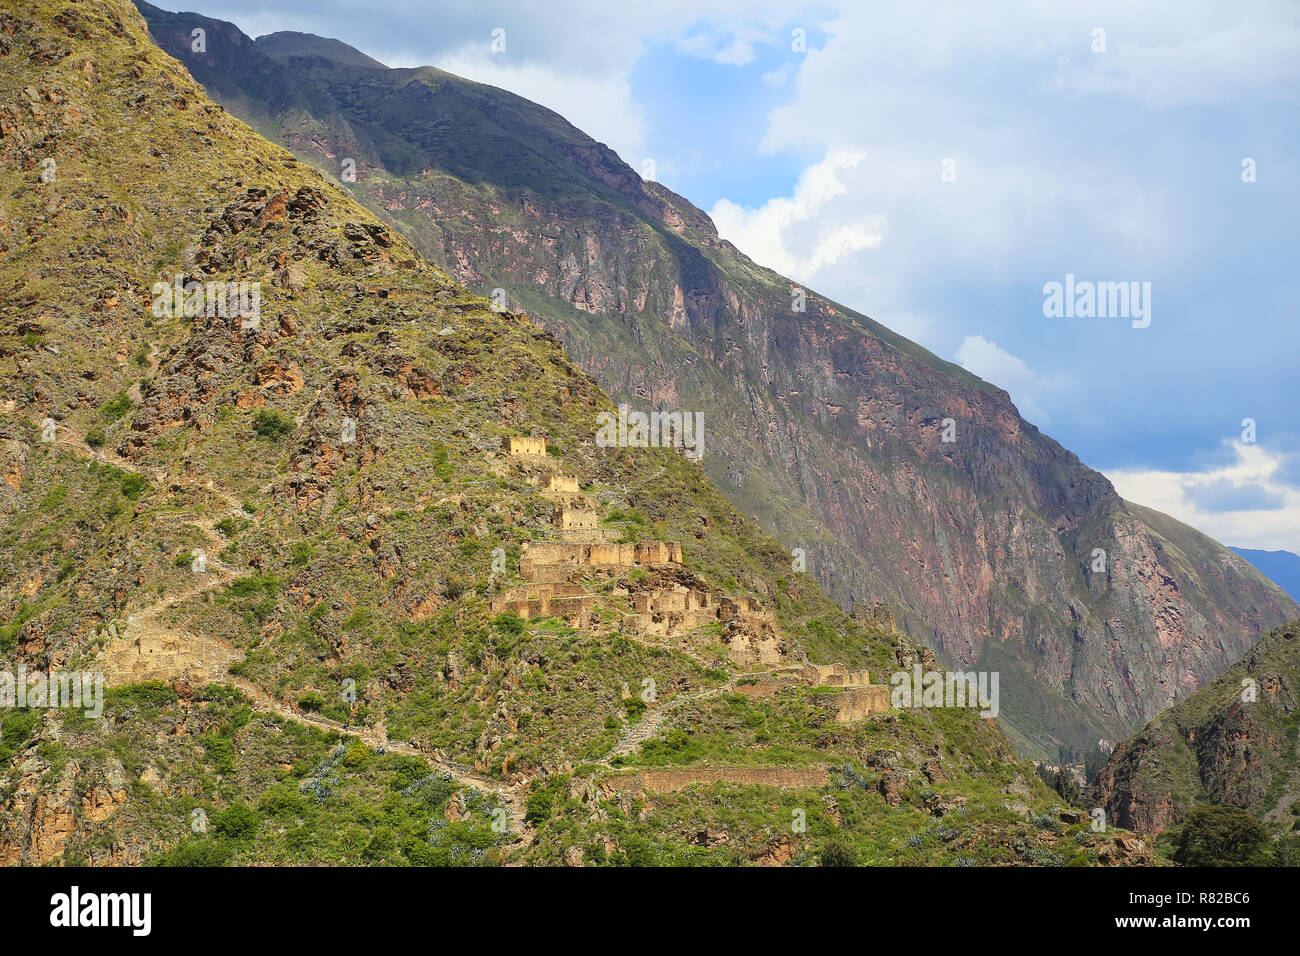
[{"left": 0, "top": 0, "right": 1151, "bottom": 865}]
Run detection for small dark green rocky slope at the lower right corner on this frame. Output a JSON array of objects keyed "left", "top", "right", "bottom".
[{"left": 1095, "top": 622, "right": 1300, "bottom": 834}]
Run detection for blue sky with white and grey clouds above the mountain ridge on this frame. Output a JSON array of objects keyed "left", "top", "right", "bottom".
[{"left": 166, "top": 0, "right": 1300, "bottom": 553}]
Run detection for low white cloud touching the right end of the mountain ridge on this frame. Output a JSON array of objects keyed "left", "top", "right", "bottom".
[{"left": 1106, "top": 441, "right": 1300, "bottom": 553}]
